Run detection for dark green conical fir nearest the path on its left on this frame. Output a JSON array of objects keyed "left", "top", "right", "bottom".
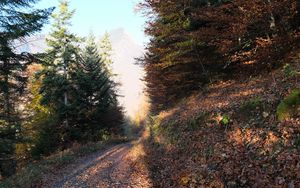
[{"left": 72, "top": 34, "right": 117, "bottom": 141}]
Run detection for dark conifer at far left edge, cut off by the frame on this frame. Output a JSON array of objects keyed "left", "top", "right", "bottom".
[{"left": 0, "top": 0, "right": 52, "bottom": 176}]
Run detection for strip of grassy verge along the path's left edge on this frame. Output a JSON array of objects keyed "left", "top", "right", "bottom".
[{"left": 0, "top": 138, "right": 127, "bottom": 188}]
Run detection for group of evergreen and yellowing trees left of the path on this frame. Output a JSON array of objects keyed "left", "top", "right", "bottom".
[{"left": 0, "top": 0, "right": 123, "bottom": 177}]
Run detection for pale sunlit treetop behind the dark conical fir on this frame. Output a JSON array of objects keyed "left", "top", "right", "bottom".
[{"left": 99, "top": 32, "right": 113, "bottom": 75}]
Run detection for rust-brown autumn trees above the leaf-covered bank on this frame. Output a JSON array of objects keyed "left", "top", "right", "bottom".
[{"left": 140, "top": 0, "right": 300, "bottom": 112}]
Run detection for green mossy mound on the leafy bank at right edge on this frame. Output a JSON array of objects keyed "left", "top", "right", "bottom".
[{"left": 277, "top": 89, "right": 300, "bottom": 121}]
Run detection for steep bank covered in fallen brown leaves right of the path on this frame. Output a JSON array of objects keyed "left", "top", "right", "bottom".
[{"left": 145, "top": 50, "right": 300, "bottom": 188}]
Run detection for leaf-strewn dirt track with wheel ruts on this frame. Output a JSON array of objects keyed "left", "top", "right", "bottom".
[{"left": 45, "top": 143, "right": 151, "bottom": 188}]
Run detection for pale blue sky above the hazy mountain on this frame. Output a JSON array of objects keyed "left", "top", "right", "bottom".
[{"left": 37, "top": 0, "right": 147, "bottom": 45}]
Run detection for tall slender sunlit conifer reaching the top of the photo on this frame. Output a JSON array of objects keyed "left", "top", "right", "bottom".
[{"left": 40, "top": 0, "right": 80, "bottom": 147}]
